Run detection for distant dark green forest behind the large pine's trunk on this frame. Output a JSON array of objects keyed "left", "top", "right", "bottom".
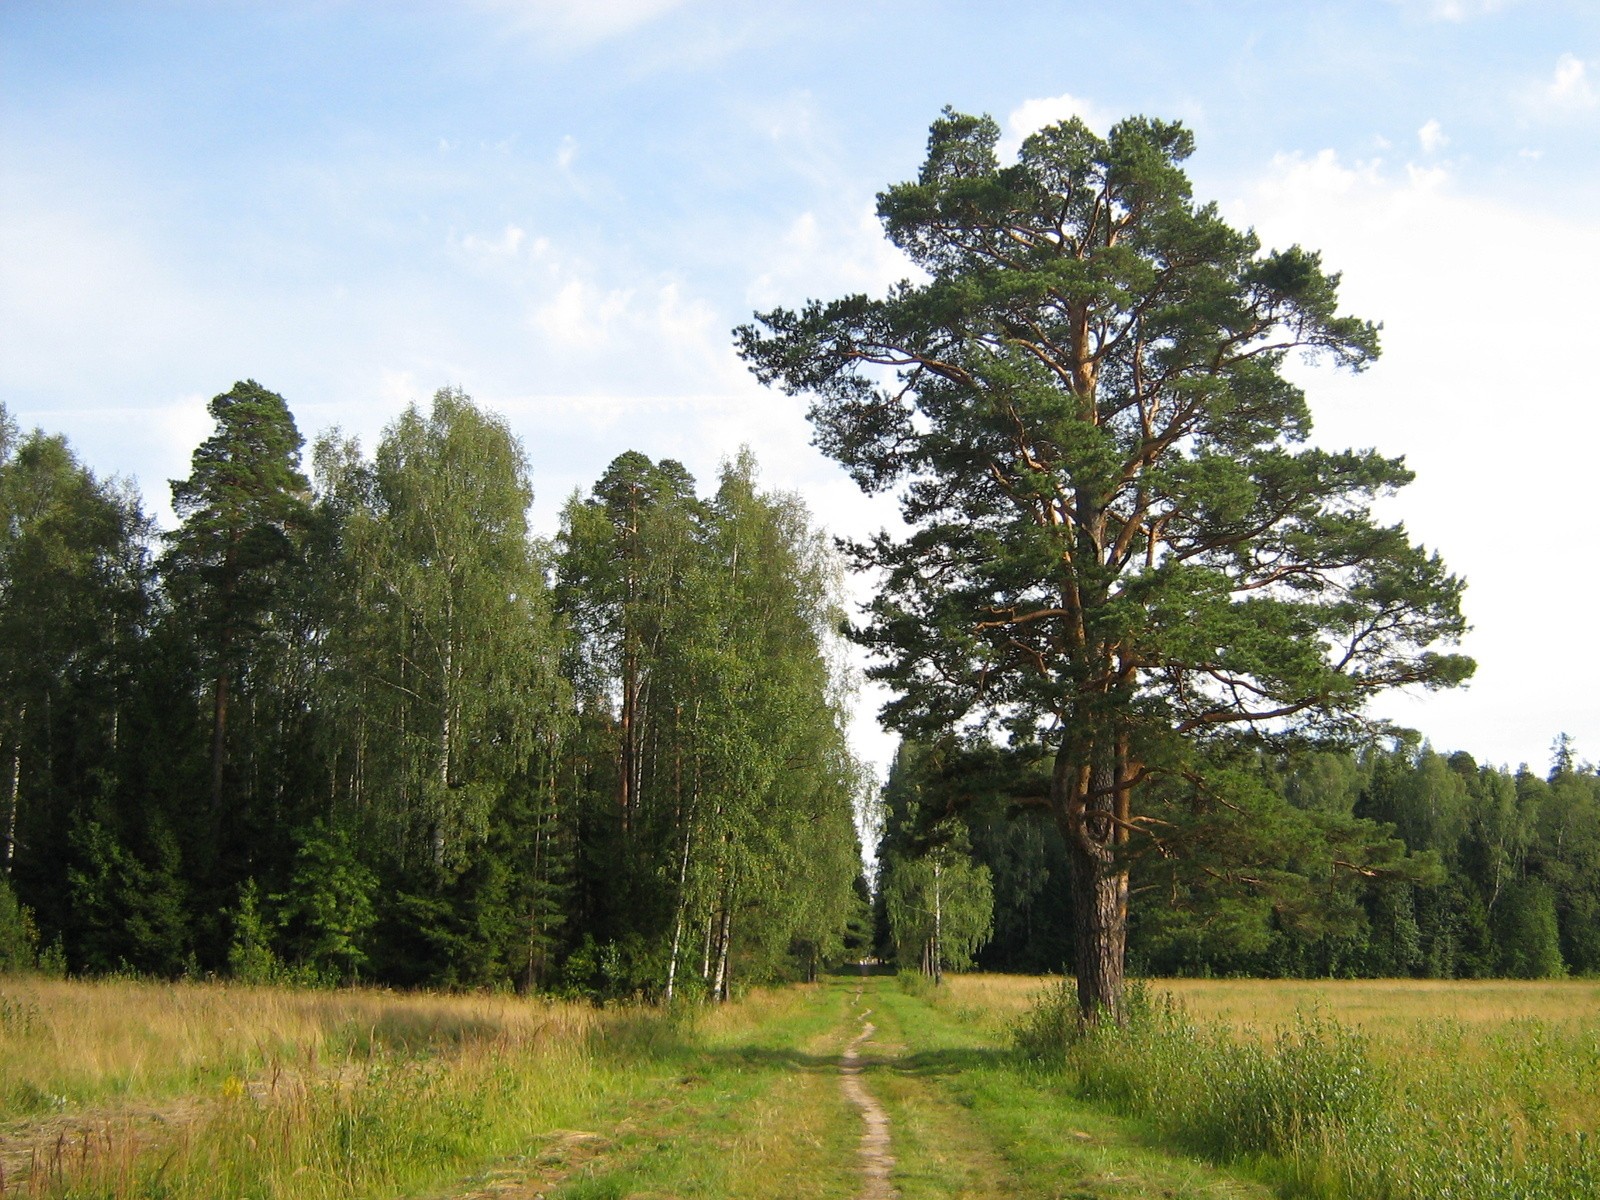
[{"left": 877, "top": 734, "right": 1600, "bottom": 979}]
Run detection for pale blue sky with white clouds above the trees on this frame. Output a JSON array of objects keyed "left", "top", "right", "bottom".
[{"left": 0, "top": 0, "right": 1600, "bottom": 784}]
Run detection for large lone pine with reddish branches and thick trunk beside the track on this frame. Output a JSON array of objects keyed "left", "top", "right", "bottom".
[{"left": 736, "top": 109, "right": 1472, "bottom": 1013}]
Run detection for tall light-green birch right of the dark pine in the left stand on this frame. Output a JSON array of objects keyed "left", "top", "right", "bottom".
[{"left": 318, "top": 389, "right": 563, "bottom": 883}]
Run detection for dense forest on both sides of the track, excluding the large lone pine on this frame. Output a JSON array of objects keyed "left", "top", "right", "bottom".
[{"left": 0, "top": 382, "right": 1600, "bottom": 997}]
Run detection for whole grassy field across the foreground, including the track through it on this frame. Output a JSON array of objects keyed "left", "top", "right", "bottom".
[{"left": 0, "top": 976, "right": 1600, "bottom": 1200}]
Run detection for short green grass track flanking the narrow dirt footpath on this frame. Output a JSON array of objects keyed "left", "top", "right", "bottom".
[{"left": 492, "top": 976, "right": 1269, "bottom": 1200}]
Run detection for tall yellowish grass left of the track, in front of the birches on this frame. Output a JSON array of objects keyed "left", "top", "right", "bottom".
[{"left": 0, "top": 981, "right": 680, "bottom": 1200}]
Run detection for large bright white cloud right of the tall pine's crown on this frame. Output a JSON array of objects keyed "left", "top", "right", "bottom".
[{"left": 1227, "top": 152, "right": 1600, "bottom": 763}]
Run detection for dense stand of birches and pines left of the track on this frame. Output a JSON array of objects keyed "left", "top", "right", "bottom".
[{"left": 0, "top": 382, "right": 866, "bottom": 997}]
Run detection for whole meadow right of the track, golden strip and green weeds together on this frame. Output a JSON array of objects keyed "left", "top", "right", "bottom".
[{"left": 998, "top": 979, "right": 1600, "bottom": 1200}]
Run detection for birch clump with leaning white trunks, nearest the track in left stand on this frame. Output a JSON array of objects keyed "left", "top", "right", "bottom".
[{"left": 557, "top": 454, "right": 861, "bottom": 998}]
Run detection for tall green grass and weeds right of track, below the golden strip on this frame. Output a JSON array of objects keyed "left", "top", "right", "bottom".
[{"left": 1018, "top": 982, "right": 1600, "bottom": 1200}]
